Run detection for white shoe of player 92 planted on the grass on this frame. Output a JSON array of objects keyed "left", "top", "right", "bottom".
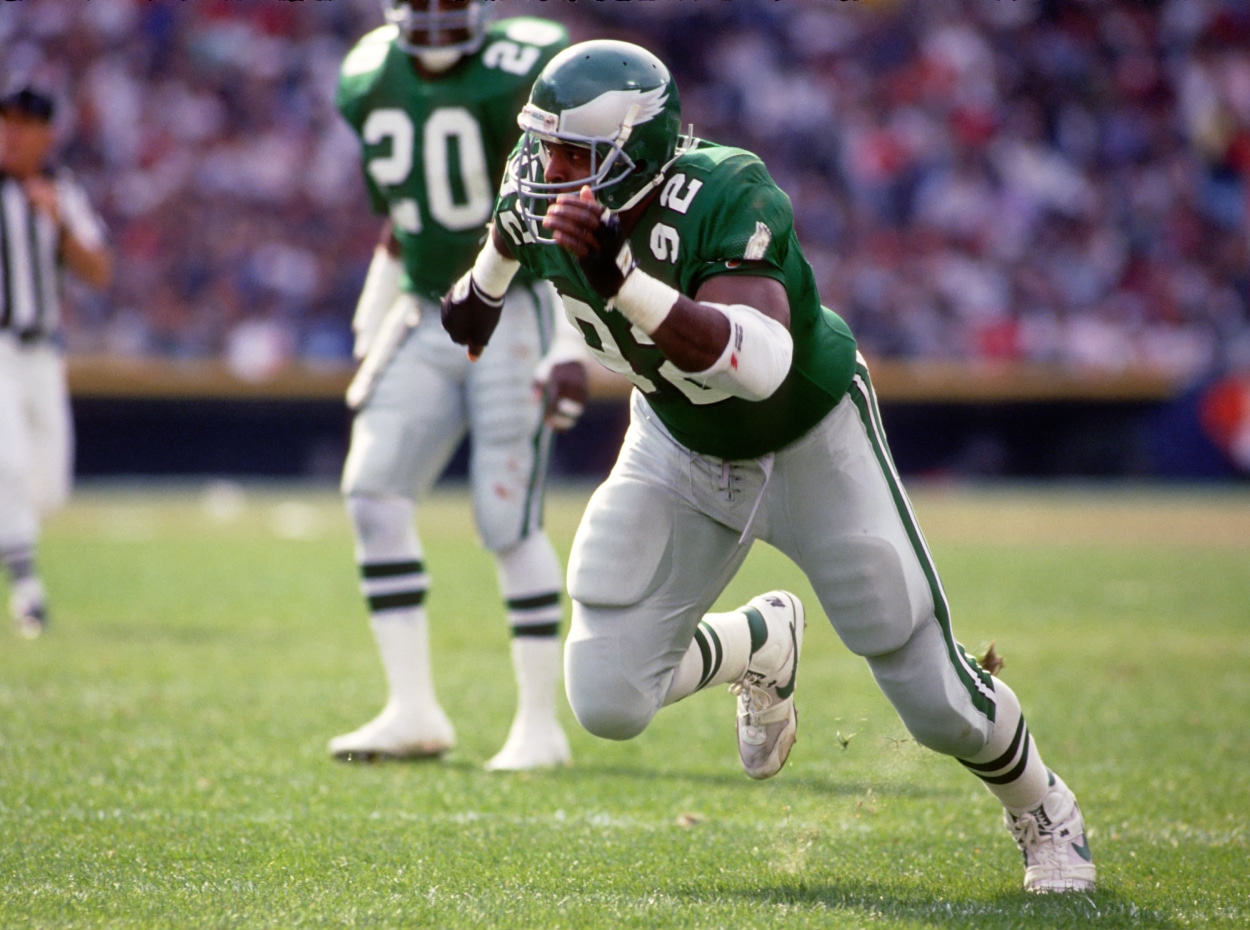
[{"left": 1003, "top": 773, "right": 1094, "bottom": 894}]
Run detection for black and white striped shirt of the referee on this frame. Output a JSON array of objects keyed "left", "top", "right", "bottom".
[{"left": 0, "top": 170, "right": 104, "bottom": 343}]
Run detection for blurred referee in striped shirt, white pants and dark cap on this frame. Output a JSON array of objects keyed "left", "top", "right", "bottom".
[{"left": 0, "top": 88, "right": 113, "bottom": 638}]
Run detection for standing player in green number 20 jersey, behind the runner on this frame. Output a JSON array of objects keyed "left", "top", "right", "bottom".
[{"left": 330, "top": 0, "right": 585, "bottom": 770}]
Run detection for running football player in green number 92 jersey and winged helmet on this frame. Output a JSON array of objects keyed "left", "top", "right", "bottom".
[{"left": 443, "top": 41, "right": 1095, "bottom": 891}]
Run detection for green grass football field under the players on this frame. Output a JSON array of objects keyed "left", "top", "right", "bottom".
[{"left": 0, "top": 488, "right": 1250, "bottom": 930}]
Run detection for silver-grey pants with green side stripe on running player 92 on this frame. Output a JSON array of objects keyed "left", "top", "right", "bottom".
[{"left": 565, "top": 364, "right": 994, "bottom": 758}]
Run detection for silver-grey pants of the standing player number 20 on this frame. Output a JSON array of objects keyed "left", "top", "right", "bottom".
[{"left": 343, "top": 283, "right": 555, "bottom": 551}]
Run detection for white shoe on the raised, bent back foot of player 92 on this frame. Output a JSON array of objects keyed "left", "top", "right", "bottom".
[{"left": 729, "top": 591, "right": 806, "bottom": 779}]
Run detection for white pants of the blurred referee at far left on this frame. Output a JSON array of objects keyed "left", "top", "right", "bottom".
[{"left": 0, "top": 333, "right": 74, "bottom": 548}]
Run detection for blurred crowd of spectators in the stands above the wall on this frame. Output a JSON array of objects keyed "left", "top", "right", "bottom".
[{"left": 0, "top": 0, "right": 1250, "bottom": 383}]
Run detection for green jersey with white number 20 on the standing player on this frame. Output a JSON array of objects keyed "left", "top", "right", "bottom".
[{"left": 336, "top": 16, "right": 569, "bottom": 300}]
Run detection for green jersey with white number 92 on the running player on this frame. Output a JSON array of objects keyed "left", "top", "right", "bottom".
[{"left": 495, "top": 141, "right": 855, "bottom": 459}]
